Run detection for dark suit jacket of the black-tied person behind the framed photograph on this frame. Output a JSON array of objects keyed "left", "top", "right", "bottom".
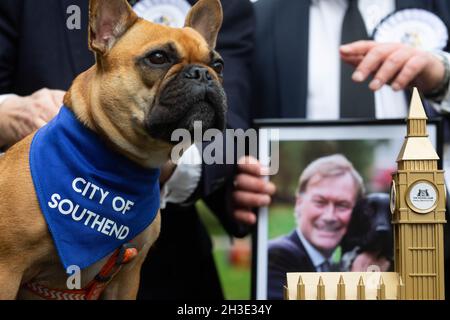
[{"left": 253, "top": 0, "right": 450, "bottom": 118}]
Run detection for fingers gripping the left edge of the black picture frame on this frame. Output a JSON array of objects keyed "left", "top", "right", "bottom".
[{"left": 233, "top": 157, "right": 276, "bottom": 225}]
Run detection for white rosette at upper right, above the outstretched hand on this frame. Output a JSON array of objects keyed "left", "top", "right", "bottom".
[{"left": 373, "top": 9, "right": 448, "bottom": 51}]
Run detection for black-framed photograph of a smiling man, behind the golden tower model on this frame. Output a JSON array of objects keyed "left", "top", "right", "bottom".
[{"left": 252, "top": 119, "right": 442, "bottom": 300}]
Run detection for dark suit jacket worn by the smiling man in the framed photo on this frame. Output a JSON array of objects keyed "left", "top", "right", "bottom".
[{"left": 267, "top": 230, "right": 316, "bottom": 300}]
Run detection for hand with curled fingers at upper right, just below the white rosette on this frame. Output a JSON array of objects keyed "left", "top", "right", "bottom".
[{"left": 340, "top": 41, "right": 445, "bottom": 94}]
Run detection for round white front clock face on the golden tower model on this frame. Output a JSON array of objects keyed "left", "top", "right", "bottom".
[{"left": 406, "top": 180, "right": 438, "bottom": 213}]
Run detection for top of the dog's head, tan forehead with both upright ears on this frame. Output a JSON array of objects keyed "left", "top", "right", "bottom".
[{"left": 89, "top": 0, "right": 223, "bottom": 68}]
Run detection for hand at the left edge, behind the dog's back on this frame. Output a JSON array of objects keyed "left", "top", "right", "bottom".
[{"left": 0, "top": 88, "right": 65, "bottom": 147}]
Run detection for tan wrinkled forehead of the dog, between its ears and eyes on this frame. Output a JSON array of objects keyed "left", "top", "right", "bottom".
[{"left": 110, "top": 20, "right": 211, "bottom": 63}]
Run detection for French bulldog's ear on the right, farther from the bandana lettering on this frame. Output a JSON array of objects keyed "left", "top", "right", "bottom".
[{"left": 184, "top": 0, "right": 223, "bottom": 49}]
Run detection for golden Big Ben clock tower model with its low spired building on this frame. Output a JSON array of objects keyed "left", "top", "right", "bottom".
[{"left": 284, "top": 89, "right": 446, "bottom": 300}]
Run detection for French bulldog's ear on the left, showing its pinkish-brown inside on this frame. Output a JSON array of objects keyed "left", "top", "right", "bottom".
[{"left": 89, "top": 0, "right": 138, "bottom": 56}]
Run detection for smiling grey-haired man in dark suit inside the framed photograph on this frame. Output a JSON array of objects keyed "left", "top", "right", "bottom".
[{"left": 268, "top": 154, "right": 364, "bottom": 299}]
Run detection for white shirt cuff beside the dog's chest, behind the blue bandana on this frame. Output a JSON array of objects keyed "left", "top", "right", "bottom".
[{"left": 160, "top": 144, "right": 202, "bottom": 209}]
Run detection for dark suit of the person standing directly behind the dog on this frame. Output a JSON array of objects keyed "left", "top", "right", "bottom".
[{"left": 0, "top": 0, "right": 254, "bottom": 299}]
